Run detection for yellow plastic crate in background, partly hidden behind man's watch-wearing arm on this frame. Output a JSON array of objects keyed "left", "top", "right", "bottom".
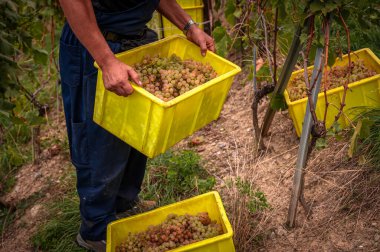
[{"left": 162, "top": 0, "right": 204, "bottom": 37}]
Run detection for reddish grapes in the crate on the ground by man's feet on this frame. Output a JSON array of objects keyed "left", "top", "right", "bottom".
[{"left": 116, "top": 212, "right": 223, "bottom": 252}]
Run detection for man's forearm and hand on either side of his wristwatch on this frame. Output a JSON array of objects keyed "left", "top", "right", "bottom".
[{"left": 158, "top": 0, "right": 215, "bottom": 56}]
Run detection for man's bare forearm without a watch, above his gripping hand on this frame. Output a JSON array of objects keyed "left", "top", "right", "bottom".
[{"left": 60, "top": 0, "right": 115, "bottom": 68}]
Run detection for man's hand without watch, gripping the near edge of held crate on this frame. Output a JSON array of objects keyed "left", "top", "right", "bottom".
[{"left": 102, "top": 58, "right": 141, "bottom": 96}]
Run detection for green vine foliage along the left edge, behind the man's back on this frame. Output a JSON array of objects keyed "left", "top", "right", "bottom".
[{"left": 0, "top": 0, "right": 63, "bottom": 189}]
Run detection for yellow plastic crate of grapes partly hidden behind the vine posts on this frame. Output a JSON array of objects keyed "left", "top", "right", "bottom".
[{"left": 284, "top": 48, "right": 380, "bottom": 136}]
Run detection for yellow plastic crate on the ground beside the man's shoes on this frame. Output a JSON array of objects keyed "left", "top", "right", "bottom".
[{"left": 107, "top": 191, "right": 235, "bottom": 252}]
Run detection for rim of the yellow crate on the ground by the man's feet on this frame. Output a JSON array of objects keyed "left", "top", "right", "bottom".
[{"left": 106, "top": 191, "right": 233, "bottom": 252}]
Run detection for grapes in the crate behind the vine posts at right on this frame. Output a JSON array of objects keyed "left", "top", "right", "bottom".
[{"left": 287, "top": 60, "right": 377, "bottom": 101}]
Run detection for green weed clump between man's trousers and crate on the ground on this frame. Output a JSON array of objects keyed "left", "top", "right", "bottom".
[{"left": 142, "top": 151, "right": 215, "bottom": 205}]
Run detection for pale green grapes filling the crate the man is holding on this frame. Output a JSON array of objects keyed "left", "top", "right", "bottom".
[{"left": 133, "top": 54, "right": 217, "bottom": 101}]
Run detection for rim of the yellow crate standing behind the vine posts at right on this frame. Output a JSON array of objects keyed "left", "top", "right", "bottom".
[{"left": 284, "top": 48, "right": 380, "bottom": 105}]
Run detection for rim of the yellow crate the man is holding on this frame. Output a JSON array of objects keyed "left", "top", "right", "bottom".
[{"left": 94, "top": 34, "right": 241, "bottom": 108}]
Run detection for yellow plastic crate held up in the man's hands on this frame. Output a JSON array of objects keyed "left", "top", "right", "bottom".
[{"left": 93, "top": 35, "right": 241, "bottom": 158}]
